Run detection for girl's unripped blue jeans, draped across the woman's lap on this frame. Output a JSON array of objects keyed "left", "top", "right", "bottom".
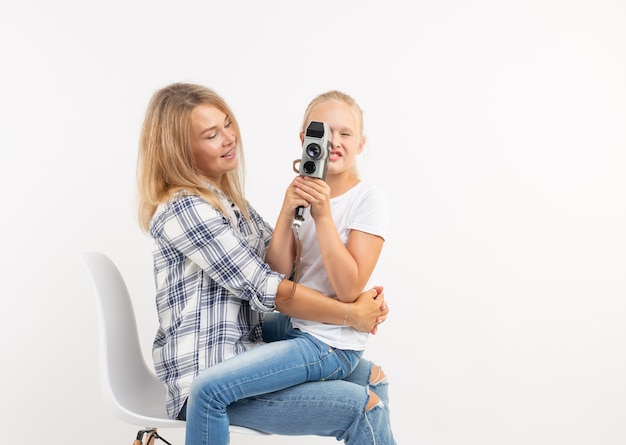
[{"left": 185, "top": 329, "right": 363, "bottom": 445}]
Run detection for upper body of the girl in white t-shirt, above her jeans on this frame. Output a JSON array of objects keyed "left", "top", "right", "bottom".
[{"left": 266, "top": 87, "right": 389, "bottom": 386}]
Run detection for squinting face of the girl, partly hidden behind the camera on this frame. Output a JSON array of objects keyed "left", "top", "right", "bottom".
[{"left": 300, "top": 100, "right": 365, "bottom": 175}]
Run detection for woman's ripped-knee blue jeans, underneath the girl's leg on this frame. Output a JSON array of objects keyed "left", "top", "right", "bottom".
[{"left": 180, "top": 316, "right": 396, "bottom": 445}]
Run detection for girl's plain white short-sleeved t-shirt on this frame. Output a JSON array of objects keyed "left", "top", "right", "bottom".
[{"left": 292, "top": 182, "right": 390, "bottom": 351}]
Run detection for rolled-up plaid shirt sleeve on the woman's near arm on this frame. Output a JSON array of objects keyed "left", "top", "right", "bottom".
[{"left": 160, "top": 196, "right": 284, "bottom": 312}]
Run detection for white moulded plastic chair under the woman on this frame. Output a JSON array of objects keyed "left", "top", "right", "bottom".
[{"left": 81, "top": 252, "right": 269, "bottom": 436}]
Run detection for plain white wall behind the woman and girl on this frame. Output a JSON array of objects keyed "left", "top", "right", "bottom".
[{"left": 0, "top": 0, "right": 626, "bottom": 445}]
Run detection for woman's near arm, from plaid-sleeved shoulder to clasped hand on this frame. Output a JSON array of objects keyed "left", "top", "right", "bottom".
[{"left": 160, "top": 196, "right": 388, "bottom": 332}]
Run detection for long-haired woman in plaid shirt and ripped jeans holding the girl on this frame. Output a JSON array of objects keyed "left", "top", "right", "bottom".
[{"left": 138, "top": 84, "right": 394, "bottom": 445}]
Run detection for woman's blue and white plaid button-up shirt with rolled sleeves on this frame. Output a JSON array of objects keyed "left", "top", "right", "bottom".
[{"left": 150, "top": 194, "right": 284, "bottom": 418}]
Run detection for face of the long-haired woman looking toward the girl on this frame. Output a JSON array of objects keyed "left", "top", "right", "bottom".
[{"left": 189, "top": 104, "right": 239, "bottom": 186}]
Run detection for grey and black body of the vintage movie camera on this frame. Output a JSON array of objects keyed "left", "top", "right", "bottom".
[{"left": 299, "top": 121, "right": 332, "bottom": 180}]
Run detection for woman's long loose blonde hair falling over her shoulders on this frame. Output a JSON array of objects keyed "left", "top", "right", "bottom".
[{"left": 137, "top": 83, "right": 249, "bottom": 232}]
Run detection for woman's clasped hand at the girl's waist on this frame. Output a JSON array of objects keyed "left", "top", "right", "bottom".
[{"left": 346, "top": 286, "right": 389, "bottom": 334}]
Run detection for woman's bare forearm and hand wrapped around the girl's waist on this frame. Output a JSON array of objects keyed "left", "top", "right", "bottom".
[{"left": 275, "top": 280, "right": 389, "bottom": 333}]
